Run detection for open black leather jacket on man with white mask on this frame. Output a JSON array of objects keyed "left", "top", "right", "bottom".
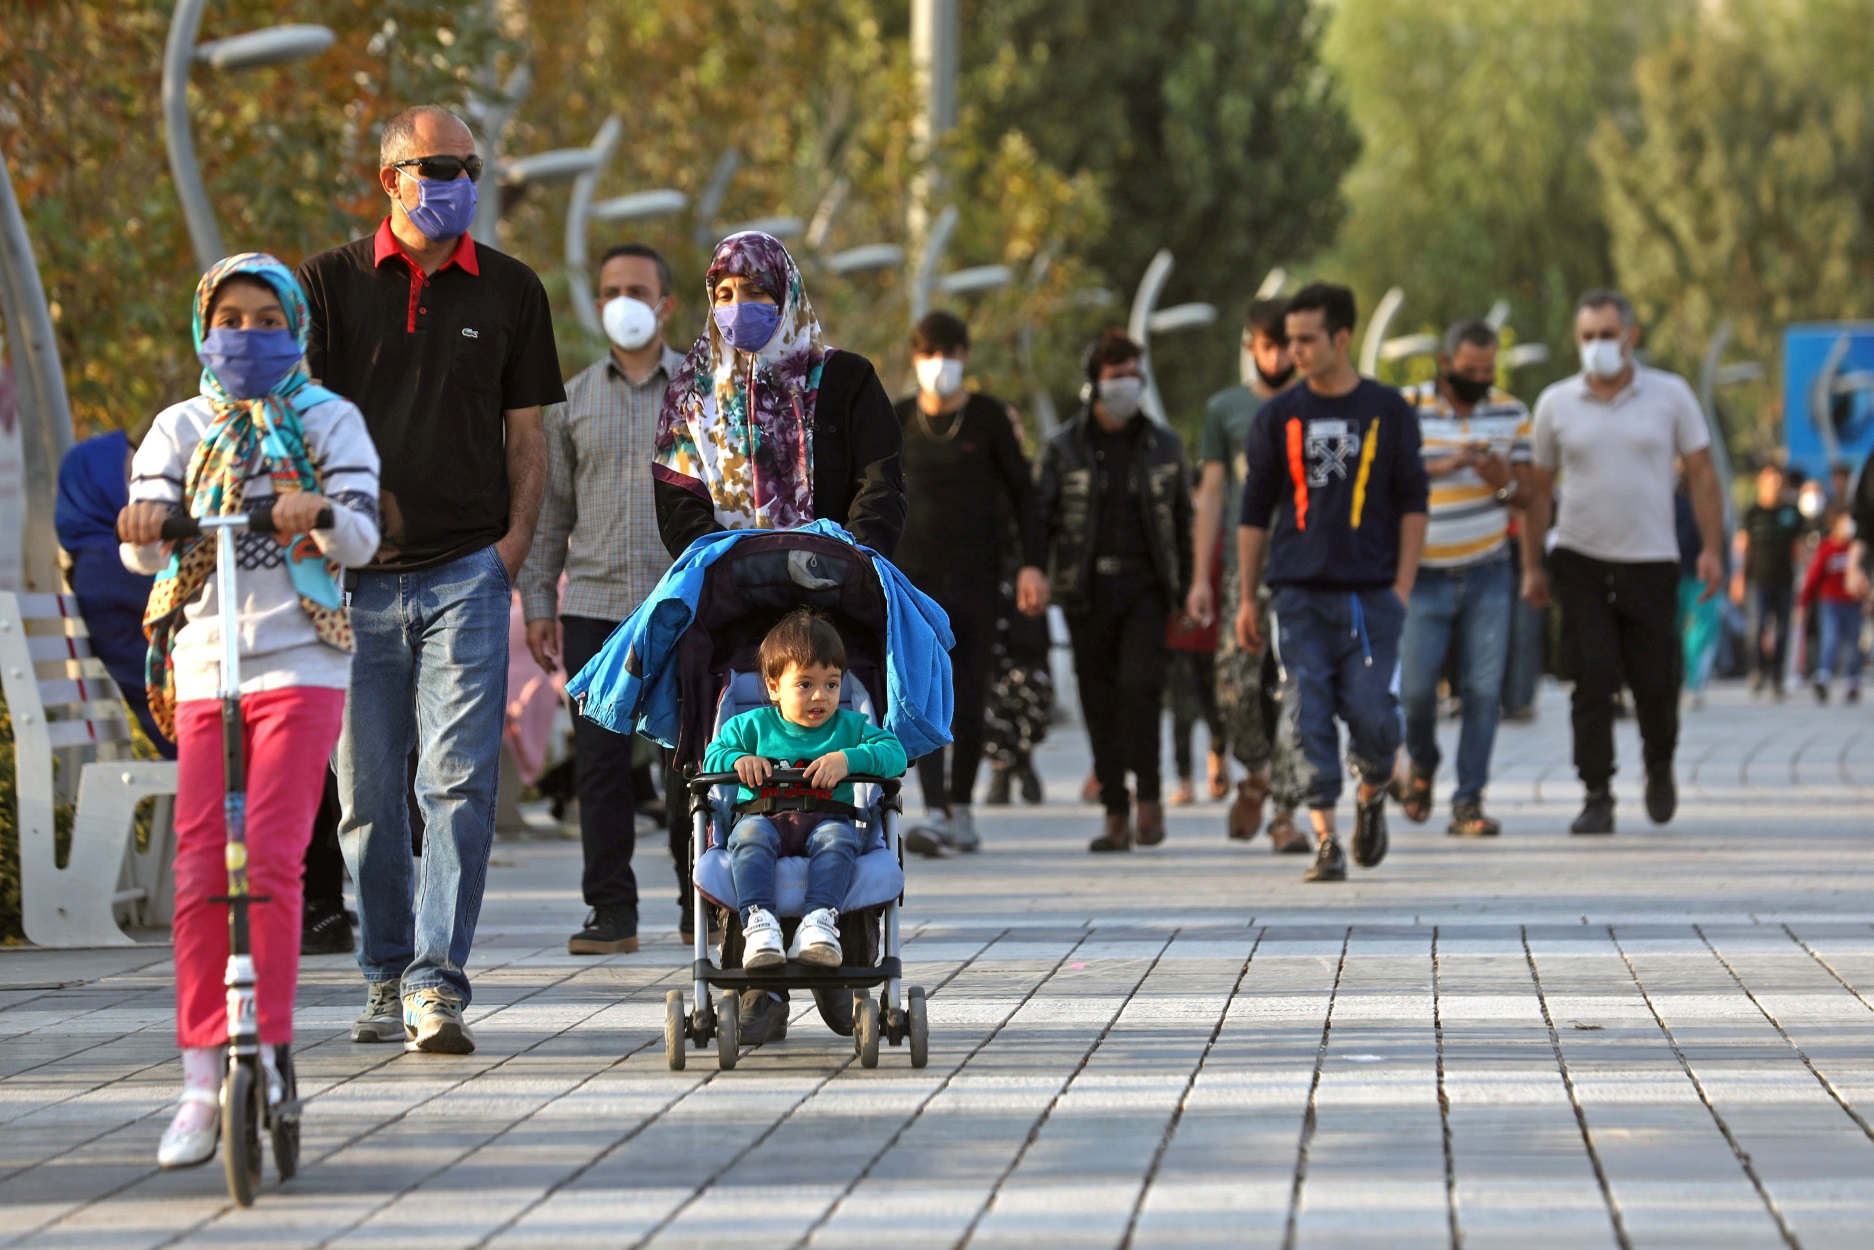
[{"left": 1034, "top": 407, "right": 1192, "bottom": 615}]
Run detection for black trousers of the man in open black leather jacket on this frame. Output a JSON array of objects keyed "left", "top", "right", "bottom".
[{"left": 1066, "top": 575, "right": 1166, "bottom": 815}]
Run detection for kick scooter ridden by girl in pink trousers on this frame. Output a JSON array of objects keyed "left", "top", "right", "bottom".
[{"left": 163, "top": 506, "right": 332, "bottom": 1207}]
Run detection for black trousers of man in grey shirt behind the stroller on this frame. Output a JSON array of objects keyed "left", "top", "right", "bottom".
[{"left": 560, "top": 617, "right": 637, "bottom": 907}]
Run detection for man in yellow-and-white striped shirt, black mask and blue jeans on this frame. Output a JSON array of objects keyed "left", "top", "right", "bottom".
[{"left": 1394, "top": 320, "right": 1535, "bottom": 838}]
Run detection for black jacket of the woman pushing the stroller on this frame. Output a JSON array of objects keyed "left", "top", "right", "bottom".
[{"left": 654, "top": 350, "right": 905, "bottom": 558}]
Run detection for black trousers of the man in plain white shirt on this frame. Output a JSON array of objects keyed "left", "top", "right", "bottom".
[{"left": 1548, "top": 547, "right": 1685, "bottom": 789}]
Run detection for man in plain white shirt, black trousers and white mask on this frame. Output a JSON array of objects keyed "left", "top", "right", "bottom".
[{"left": 1524, "top": 290, "right": 1724, "bottom": 834}]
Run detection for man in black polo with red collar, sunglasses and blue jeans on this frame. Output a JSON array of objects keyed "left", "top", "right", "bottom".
[{"left": 300, "top": 107, "right": 566, "bottom": 1053}]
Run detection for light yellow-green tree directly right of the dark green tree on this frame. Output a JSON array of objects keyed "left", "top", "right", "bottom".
[{"left": 1319, "top": 0, "right": 1668, "bottom": 384}]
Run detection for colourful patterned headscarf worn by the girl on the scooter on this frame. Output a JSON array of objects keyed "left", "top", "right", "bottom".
[{"left": 142, "top": 251, "right": 352, "bottom": 738}]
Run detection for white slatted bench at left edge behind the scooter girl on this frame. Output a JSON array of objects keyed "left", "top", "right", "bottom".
[{"left": 0, "top": 592, "right": 176, "bottom": 946}]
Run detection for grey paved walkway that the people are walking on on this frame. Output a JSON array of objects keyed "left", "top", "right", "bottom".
[{"left": 0, "top": 692, "right": 1874, "bottom": 1250}]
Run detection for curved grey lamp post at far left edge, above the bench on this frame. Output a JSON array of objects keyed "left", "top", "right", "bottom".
[{"left": 0, "top": 159, "right": 71, "bottom": 590}]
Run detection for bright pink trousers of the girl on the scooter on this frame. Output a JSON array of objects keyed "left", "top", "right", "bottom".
[{"left": 174, "top": 686, "right": 345, "bottom": 1046}]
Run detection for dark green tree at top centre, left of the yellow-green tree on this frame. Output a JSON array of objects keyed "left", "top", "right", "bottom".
[{"left": 961, "top": 0, "right": 1357, "bottom": 434}]
